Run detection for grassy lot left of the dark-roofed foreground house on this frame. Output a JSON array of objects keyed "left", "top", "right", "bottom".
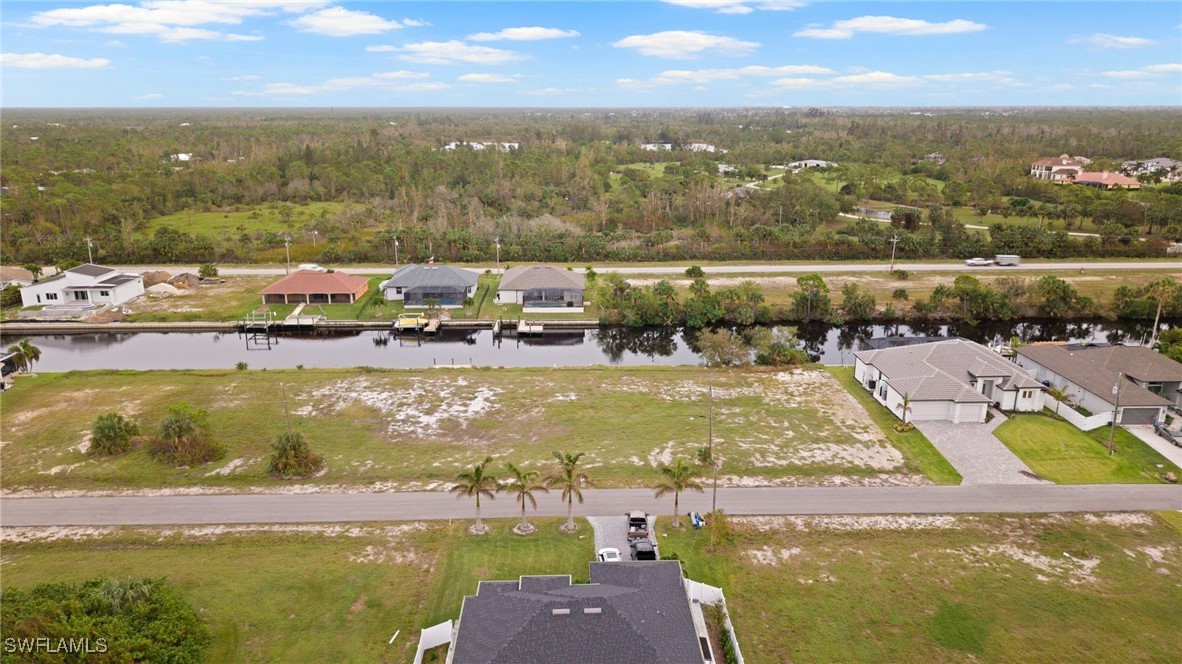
[{"left": 2, "top": 520, "right": 595, "bottom": 663}]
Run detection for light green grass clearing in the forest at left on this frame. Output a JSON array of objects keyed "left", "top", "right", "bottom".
[{"left": 138, "top": 202, "right": 349, "bottom": 238}]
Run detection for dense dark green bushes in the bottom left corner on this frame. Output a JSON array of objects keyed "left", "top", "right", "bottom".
[{"left": 0, "top": 579, "right": 213, "bottom": 662}]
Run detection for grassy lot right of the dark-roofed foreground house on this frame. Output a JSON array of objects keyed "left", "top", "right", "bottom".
[{"left": 661, "top": 514, "right": 1182, "bottom": 664}]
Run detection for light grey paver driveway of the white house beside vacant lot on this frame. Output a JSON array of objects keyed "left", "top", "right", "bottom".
[{"left": 915, "top": 411, "right": 1045, "bottom": 484}]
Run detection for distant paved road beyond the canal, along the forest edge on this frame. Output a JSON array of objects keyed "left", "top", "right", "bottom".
[{"left": 111, "top": 261, "right": 1182, "bottom": 276}]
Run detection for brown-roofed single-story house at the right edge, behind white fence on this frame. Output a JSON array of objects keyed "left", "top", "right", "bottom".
[{"left": 1017, "top": 344, "right": 1182, "bottom": 424}]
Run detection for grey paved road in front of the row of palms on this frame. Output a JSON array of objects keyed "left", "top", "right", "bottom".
[{"left": 0, "top": 484, "right": 1182, "bottom": 526}]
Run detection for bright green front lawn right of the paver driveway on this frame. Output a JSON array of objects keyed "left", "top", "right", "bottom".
[{"left": 994, "top": 415, "right": 1182, "bottom": 484}]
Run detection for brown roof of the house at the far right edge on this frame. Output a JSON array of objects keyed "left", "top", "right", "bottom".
[{"left": 1018, "top": 344, "right": 1182, "bottom": 406}]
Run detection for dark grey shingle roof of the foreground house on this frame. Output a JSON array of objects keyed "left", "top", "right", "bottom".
[{"left": 453, "top": 560, "right": 702, "bottom": 664}]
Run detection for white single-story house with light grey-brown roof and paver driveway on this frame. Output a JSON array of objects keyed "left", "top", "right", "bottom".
[{"left": 853, "top": 339, "right": 1046, "bottom": 423}]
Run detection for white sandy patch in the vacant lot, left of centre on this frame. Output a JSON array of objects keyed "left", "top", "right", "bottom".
[{"left": 296, "top": 376, "right": 501, "bottom": 438}]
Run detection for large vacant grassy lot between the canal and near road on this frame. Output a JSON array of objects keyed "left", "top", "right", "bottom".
[{"left": 0, "top": 367, "right": 931, "bottom": 493}]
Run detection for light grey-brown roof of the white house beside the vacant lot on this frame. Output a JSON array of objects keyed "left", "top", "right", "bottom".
[{"left": 853, "top": 339, "right": 1044, "bottom": 403}]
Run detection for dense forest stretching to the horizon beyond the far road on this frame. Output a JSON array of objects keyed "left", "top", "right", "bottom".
[{"left": 0, "top": 109, "right": 1182, "bottom": 265}]
